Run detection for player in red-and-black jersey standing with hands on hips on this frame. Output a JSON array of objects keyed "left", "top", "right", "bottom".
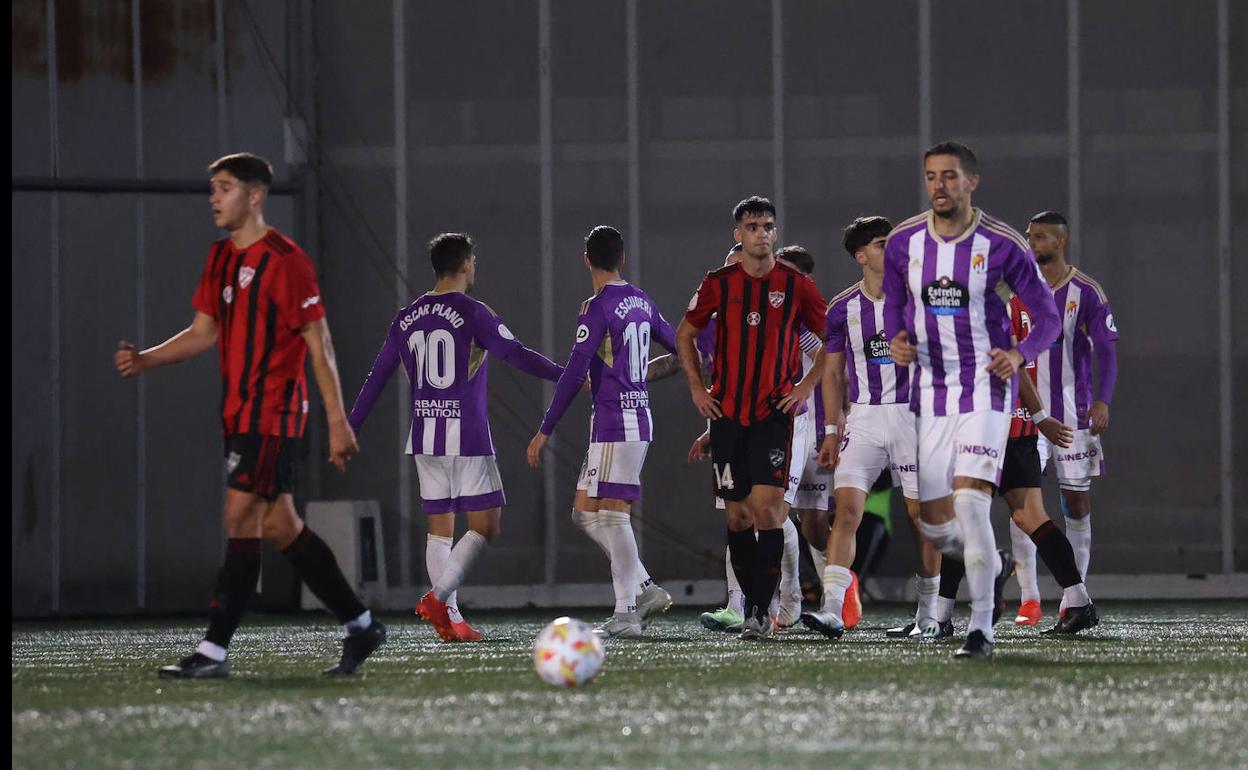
[{"left": 676, "top": 197, "right": 825, "bottom": 640}]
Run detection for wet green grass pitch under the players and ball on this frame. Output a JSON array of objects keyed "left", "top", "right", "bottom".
[{"left": 11, "top": 603, "right": 1248, "bottom": 770}]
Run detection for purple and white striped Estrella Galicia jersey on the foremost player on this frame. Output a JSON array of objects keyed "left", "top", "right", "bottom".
[{"left": 884, "top": 208, "right": 1058, "bottom": 416}]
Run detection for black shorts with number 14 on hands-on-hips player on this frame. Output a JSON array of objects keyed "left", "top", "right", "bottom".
[{"left": 710, "top": 412, "right": 792, "bottom": 503}]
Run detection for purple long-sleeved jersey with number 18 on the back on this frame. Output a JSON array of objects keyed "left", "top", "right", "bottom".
[{"left": 542, "top": 281, "right": 676, "bottom": 442}]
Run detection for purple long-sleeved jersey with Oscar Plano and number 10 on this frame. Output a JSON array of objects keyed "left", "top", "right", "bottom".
[{"left": 348, "top": 292, "right": 563, "bottom": 457}]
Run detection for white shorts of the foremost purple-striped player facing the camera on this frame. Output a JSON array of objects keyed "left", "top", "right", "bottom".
[{"left": 919, "top": 409, "right": 1011, "bottom": 503}]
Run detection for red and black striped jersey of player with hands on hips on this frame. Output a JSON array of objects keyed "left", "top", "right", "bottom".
[{"left": 685, "top": 262, "right": 826, "bottom": 426}]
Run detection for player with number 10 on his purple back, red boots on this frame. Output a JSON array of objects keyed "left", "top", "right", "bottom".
[{"left": 351, "top": 232, "right": 563, "bottom": 641}]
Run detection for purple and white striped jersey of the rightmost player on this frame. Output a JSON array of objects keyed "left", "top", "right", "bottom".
[{"left": 1036, "top": 267, "right": 1118, "bottom": 428}]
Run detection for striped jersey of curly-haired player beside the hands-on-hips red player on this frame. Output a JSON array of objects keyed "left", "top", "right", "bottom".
[{"left": 824, "top": 281, "right": 910, "bottom": 404}]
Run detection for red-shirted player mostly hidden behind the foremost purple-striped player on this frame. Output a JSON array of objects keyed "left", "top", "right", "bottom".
[{"left": 937, "top": 297, "right": 1099, "bottom": 634}]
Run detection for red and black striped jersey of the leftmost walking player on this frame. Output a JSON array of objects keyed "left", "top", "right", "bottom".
[{"left": 191, "top": 224, "right": 324, "bottom": 438}]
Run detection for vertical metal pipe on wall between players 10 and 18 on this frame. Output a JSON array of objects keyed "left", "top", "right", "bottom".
[{"left": 538, "top": 0, "right": 559, "bottom": 585}]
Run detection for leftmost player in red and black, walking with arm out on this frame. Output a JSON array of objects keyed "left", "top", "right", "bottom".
[{"left": 115, "top": 152, "right": 386, "bottom": 679}]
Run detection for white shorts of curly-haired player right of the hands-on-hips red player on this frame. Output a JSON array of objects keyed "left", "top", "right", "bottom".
[{"left": 834, "top": 403, "right": 919, "bottom": 500}]
